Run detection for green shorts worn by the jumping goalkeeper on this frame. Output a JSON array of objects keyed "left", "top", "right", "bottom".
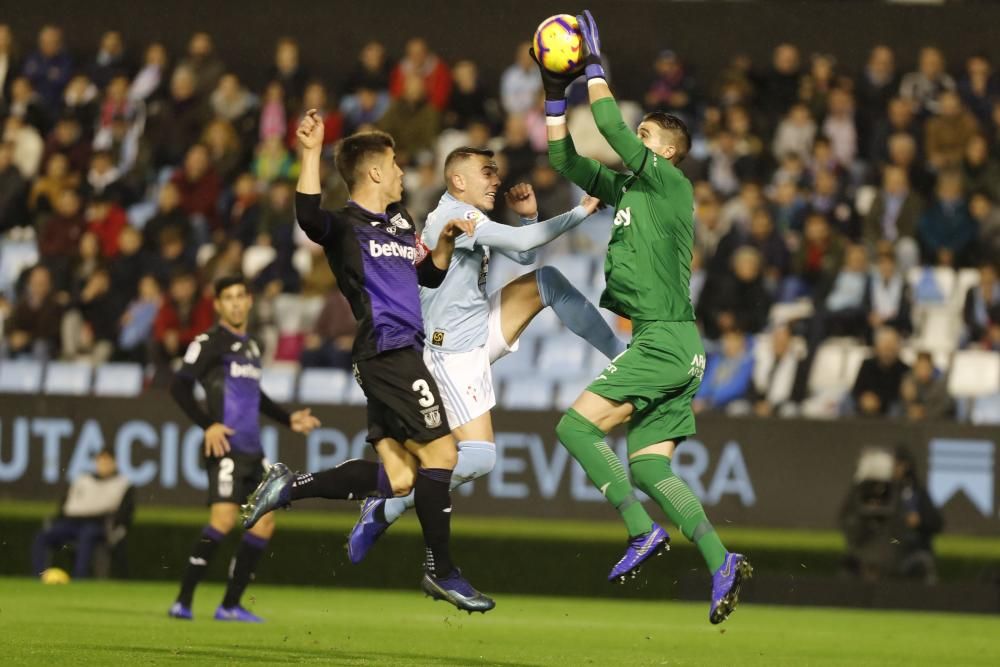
[{"left": 587, "top": 322, "right": 705, "bottom": 454}]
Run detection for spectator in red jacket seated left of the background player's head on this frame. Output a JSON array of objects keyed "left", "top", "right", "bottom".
[{"left": 153, "top": 272, "right": 214, "bottom": 381}]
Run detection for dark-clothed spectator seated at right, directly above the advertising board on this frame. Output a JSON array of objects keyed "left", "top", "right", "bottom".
[{"left": 851, "top": 327, "right": 910, "bottom": 417}]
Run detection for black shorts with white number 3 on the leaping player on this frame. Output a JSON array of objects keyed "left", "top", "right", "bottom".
[{"left": 354, "top": 347, "right": 451, "bottom": 445}]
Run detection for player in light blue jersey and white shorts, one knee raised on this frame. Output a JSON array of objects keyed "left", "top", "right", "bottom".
[{"left": 348, "top": 148, "right": 625, "bottom": 563}]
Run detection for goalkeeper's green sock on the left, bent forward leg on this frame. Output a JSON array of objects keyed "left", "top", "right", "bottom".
[{"left": 556, "top": 408, "right": 653, "bottom": 537}]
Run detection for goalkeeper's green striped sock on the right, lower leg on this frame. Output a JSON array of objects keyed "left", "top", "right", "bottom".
[{"left": 630, "top": 454, "right": 727, "bottom": 574}]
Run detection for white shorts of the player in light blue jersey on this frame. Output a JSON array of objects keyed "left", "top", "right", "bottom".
[{"left": 424, "top": 290, "right": 518, "bottom": 429}]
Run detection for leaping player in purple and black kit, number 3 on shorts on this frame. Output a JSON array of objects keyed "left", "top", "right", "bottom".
[{"left": 244, "top": 111, "right": 495, "bottom": 613}]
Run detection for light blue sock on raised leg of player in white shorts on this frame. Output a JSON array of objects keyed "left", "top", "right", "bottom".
[{"left": 535, "top": 266, "right": 626, "bottom": 359}]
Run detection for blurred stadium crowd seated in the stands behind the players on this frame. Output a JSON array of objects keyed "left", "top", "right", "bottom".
[{"left": 0, "top": 25, "right": 1000, "bottom": 421}]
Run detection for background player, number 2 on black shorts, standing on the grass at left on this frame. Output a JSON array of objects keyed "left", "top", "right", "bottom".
[{"left": 169, "top": 277, "right": 320, "bottom": 623}]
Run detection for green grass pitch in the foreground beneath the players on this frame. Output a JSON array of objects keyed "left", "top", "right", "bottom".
[{"left": 0, "top": 579, "right": 1000, "bottom": 666}]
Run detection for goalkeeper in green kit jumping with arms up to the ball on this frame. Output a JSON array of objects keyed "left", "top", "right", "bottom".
[{"left": 536, "top": 11, "right": 753, "bottom": 623}]
